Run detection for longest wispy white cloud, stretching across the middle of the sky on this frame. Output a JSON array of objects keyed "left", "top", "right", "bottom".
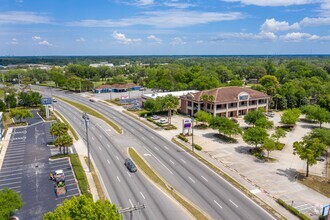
[{"left": 67, "top": 10, "right": 244, "bottom": 28}]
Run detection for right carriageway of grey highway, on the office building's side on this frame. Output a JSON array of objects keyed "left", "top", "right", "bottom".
[{"left": 34, "top": 85, "right": 274, "bottom": 220}]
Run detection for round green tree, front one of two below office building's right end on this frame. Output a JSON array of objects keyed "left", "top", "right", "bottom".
[{"left": 243, "top": 127, "right": 268, "bottom": 147}]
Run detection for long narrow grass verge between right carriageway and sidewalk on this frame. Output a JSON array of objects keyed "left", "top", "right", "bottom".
[{"left": 172, "top": 138, "right": 286, "bottom": 219}]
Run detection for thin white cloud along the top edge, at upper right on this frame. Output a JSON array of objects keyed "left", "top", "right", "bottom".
[{"left": 223, "top": 0, "right": 320, "bottom": 6}]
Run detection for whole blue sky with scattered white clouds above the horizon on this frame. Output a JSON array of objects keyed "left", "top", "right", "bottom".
[{"left": 0, "top": 0, "right": 330, "bottom": 56}]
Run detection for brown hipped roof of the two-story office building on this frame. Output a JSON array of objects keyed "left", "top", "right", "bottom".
[{"left": 184, "top": 86, "right": 269, "bottom": 103}]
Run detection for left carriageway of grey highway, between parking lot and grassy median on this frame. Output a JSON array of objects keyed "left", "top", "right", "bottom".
[{"left": 54, "top": 100, "right": 190, "bottom": 220}]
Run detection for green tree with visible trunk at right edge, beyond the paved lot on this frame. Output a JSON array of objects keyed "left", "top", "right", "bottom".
[{"left": 301, "top": 105, "right": 330, "bottom": 128}]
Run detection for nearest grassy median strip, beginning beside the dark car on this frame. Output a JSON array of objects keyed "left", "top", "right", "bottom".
[{"left": 128, "top": 148, "right": 208, "bottom": 220}]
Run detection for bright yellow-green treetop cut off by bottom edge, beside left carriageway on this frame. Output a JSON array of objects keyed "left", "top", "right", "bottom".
[{"left": 44, "top": 195, "right": 121, "bottom": 220}]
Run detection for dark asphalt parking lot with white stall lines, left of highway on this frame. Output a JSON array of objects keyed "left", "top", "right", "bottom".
[{"left": 0, "top": 111, "right": 79, "bottom": 220}]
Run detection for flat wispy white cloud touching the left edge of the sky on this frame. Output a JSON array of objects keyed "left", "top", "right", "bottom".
[{"left": 0, "top": 11, "right": 50, "bottom": 24}]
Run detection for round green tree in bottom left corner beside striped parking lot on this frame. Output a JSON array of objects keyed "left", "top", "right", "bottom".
[{"left": 0, "top": 189, "right": 23, "bottom": 219}]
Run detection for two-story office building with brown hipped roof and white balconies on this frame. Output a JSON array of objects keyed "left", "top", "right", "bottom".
[{"left": 180, "top": 86, "right": 270, "bottom": 117}]
